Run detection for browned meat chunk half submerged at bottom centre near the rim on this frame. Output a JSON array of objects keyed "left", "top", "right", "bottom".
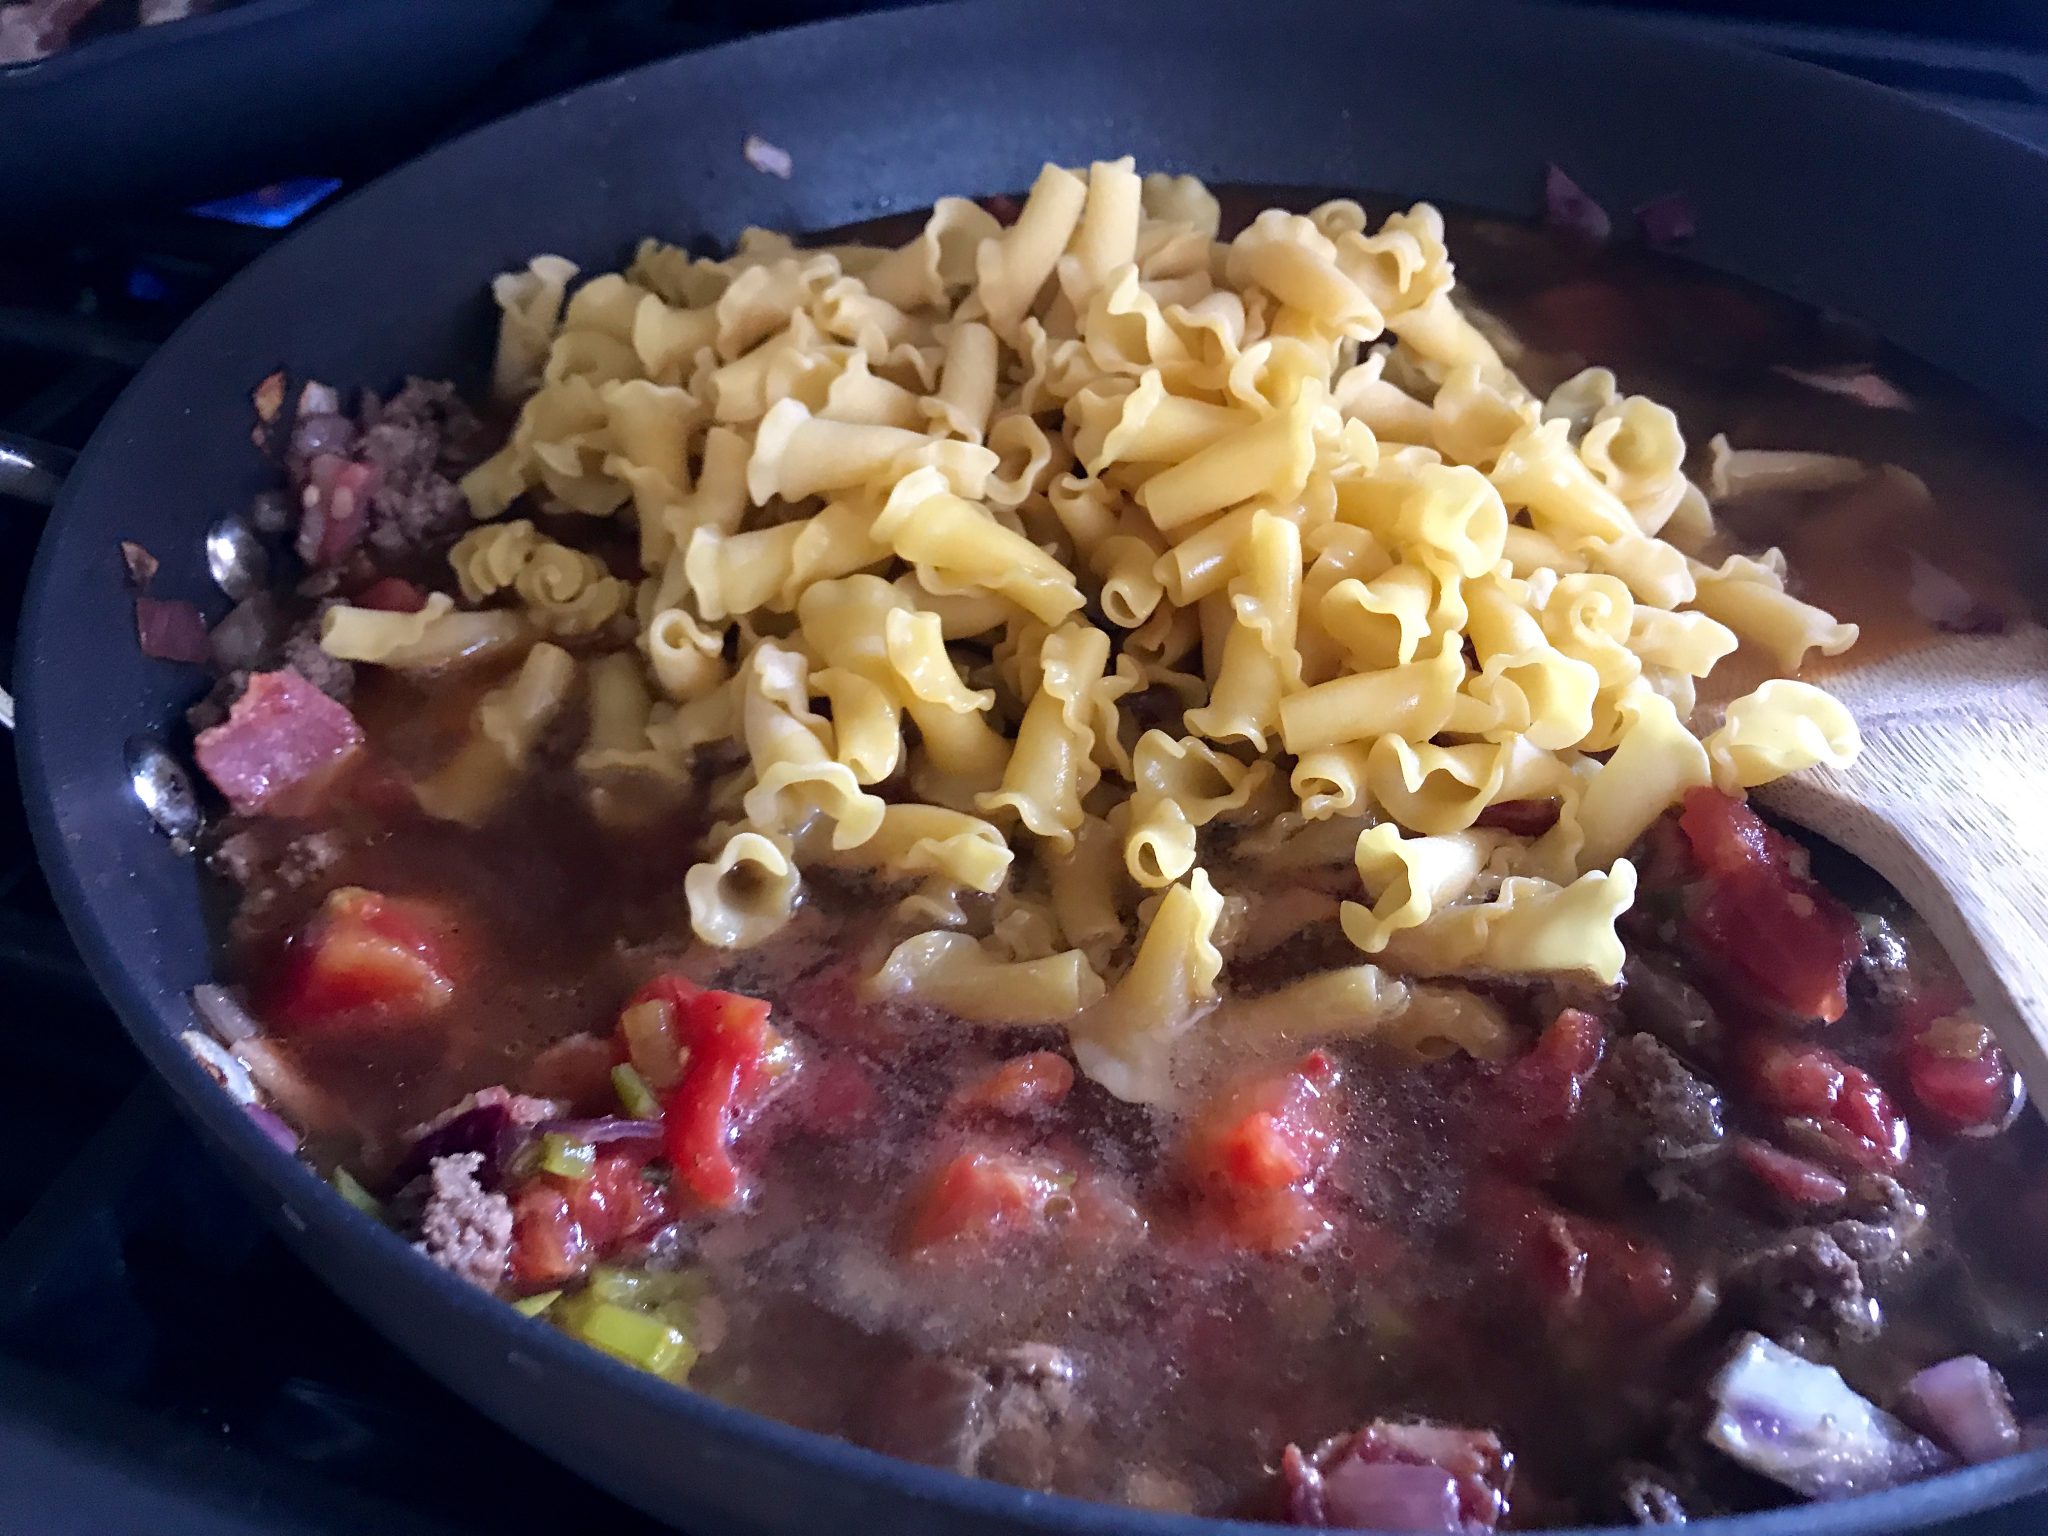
[{"left": 864, "top": 1343, "right": 1085, "bottom": 1489}]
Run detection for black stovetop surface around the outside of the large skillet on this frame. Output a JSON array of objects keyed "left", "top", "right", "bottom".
[{"left": 0, "top": 0, "right": 2048, "bottom": 1536}]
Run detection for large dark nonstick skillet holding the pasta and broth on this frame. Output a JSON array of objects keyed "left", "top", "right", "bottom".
[{"left": 18, "top": 0, "right": 2048, "bottom": 1536}]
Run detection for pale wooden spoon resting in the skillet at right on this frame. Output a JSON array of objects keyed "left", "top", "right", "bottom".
[{"left": 1757, "top": 625, "right": 2048, "bottom": 1114}]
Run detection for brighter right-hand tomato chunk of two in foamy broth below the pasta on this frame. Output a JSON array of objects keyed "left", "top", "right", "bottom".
[{"left": 1182, "top": 1051, "right": 1341, "bottom": 1253}]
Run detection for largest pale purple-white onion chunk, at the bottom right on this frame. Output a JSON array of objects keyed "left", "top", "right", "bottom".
[{"left": 1706, "top": 1333, "right": 1952, "bottom": 1499}]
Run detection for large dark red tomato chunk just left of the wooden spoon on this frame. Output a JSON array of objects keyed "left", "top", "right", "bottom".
[{"left": 1679, "top": 788, "right": 1864, "bottom": 1024}]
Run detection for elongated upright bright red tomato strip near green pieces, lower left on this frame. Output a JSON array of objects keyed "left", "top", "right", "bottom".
[{"left": 629, "top": 975, "right": 788, "bottom": 1206}]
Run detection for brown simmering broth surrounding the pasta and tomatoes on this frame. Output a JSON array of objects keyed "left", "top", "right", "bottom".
[{"left": 216, "top": 195, "right": 2048, "bottom": 1526}]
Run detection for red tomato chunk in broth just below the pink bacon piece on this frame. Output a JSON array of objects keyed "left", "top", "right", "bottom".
[{"left": 266, "top": 885, "right": 457, "bottom": 1030}]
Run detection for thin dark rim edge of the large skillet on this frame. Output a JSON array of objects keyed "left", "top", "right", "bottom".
[{"left": 16, "top": 0, "right": 2048, "bottom": 1536}]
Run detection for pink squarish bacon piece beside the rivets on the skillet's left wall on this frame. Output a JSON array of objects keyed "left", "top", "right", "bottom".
[{"left": 193, "top": 668, "right": 362, "bottom": 815}]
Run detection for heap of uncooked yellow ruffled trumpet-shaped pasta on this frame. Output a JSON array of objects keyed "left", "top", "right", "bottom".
[{"left": 324, "top": 160, "right": 1858, "bottom": 1100}]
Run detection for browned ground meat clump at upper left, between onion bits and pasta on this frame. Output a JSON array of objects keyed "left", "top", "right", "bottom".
[{"left": 356, "top": 379, "right": 481, "bottom": 555}]
